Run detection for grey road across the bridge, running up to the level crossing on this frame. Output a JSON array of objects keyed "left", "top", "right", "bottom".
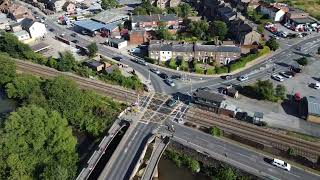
[{"left": 98, "top": 123, "right": 156, "bottom": 180}]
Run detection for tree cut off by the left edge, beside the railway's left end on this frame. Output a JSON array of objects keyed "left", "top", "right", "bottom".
[{"left": 0, "top": 54, "right": 16, "bottom": 86}]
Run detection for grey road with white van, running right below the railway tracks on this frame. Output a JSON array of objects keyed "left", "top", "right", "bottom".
[{"left": 159, "top": 122, "right": 320, "bottom": 180}]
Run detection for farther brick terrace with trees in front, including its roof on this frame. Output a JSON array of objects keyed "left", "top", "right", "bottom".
[{"left": 131, "top": 14, "right": 179, "bottom": 31}]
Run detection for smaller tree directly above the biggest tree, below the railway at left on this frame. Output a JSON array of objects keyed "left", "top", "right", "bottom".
[{"left": 6, "top": 75, "right": 41, "bottom": 99}]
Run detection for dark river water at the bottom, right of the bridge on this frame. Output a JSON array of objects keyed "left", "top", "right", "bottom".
[{"left": 158, "top": 156, "right": 210, "bottom": 180}]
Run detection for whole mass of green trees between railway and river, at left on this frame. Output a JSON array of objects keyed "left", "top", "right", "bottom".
[{"left": 0, "top": 54, "right": 124, "bottom": 179}]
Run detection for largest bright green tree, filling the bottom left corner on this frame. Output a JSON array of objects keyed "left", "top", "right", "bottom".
[{"left": 0, "top": 106, "right": 78, "bottom": 179}]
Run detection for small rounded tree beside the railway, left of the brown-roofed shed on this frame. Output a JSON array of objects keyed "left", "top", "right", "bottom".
[{"left": 57, "top": 51, "right": 77, "bottom": 71}]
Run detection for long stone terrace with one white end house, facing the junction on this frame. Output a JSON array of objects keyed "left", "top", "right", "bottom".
[{"left": 148, "top": 41, "right": 241, "bottom": 65}]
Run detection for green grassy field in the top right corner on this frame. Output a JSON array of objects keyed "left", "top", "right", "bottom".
[{"left": 277, "top": 0, "right": 320, "bottom": 20}]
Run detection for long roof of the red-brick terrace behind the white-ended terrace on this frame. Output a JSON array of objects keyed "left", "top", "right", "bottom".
[{"left": 132, "top": 14, "right": 178, "bottom": 23}]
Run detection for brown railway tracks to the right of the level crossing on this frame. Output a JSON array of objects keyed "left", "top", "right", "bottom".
[{"left": 184, "top": 108, "right": 320, "bottom": 160}]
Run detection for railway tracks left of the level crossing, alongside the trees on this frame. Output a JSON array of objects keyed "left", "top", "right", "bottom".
[{"left": 16, "top": 60, "right": 137, "bottom": 103}]
